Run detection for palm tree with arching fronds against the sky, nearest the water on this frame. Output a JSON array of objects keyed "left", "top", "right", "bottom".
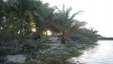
[{"left": 53, "top": 6, "right": 82, "bottom": 43}]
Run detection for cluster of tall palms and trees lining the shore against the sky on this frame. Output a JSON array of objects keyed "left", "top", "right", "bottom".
[{"left": 0, "top": 0, "right": 86, "bottom": 43}]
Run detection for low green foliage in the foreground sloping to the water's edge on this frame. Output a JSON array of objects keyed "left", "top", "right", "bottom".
[{"left": 26, "top": 45, "right": 80, "bottom": 64}]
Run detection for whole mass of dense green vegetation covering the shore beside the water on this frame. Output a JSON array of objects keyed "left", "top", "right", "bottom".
[{"left": 0, "top": 0, "right": 97, "bottom": 64}]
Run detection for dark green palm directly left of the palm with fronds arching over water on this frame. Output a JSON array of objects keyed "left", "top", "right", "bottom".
[{"left": 35, "top": 3, "right": 55, "bottom": 34}]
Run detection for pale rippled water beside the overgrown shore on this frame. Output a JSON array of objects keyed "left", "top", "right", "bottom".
[{"left": 73, "top": 40, "right": 113, "bottom": 64}]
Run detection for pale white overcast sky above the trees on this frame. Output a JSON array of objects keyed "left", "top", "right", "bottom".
[{"left": 43, "top": 0, "right": 113, "bottom": 37}]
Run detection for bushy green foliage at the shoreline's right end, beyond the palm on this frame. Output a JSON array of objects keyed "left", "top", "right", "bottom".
[{"left": 70, "top": 28, "right": 97, "bottom": 45}]
